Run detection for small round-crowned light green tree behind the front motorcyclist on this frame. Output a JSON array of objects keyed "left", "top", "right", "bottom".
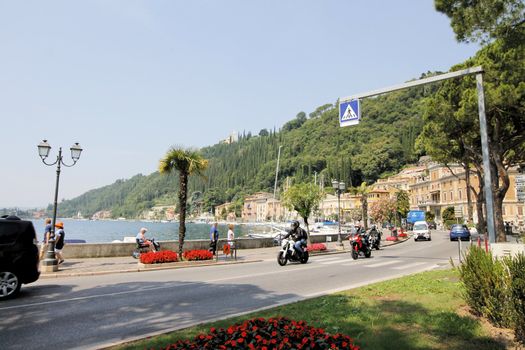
[{"left": 281, "top": 183, "right": 325, "bottom": 245}]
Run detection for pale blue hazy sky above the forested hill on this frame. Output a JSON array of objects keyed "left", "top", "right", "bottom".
[{"left": 0, "top": 0, "right": 479, "bottom": 208}]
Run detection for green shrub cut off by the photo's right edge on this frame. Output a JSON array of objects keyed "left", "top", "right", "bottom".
[{"left": 504, "top": 254, "right": 525, "bottom": 343}]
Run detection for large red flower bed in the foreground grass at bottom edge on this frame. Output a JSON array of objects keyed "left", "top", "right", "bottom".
[{"left": 165, "top": 317, "right": 359, "bottom": 350}]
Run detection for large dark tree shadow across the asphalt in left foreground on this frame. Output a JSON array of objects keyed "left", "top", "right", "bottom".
[{"left": 0, "top": 281, "right": 297, "bottom": 349}]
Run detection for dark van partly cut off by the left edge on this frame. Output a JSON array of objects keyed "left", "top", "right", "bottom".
[{"left": 0, "top": 216, "right": 40, "bottom": 300}]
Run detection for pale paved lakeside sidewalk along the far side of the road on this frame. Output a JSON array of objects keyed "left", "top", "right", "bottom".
[{"left": 40, "top": 237, "right": 406, "bottom": 278}]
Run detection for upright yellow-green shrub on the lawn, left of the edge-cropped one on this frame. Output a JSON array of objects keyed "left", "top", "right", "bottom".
[{"left": 458, "top": 246, "right": 511, "bottom": 326}]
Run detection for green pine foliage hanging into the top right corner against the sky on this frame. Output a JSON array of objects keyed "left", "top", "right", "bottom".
[{"left": 435, "top": 0, "right": 525, "bottom": 43}]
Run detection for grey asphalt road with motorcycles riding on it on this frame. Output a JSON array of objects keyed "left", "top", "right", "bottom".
[{"left": 0, "top": 231, "right": 467, "bottom": 349}]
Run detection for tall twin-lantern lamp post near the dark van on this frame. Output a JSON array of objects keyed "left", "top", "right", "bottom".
[{"left": 38, "top": 140, "right": 82, "bottom": 272}]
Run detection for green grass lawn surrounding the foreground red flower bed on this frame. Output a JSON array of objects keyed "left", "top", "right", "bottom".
[{"left": 111, "top": 270, "right": 506, "bottom": 350}]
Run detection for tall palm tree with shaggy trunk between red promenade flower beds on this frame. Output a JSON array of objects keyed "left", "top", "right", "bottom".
[{"left": 159, "top": 146, "right": 208, "bottom": 256}]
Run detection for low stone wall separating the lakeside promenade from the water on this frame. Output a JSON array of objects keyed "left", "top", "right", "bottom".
[{"left": 47, "top": 235, "right": 345, "bottom": 259}]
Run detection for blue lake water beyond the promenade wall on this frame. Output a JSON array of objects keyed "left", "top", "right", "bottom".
[{"left": 32, "top": 219, "right": 270, "bottom": 243}]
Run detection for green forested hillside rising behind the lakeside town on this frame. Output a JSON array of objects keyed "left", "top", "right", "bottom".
[{"left": 55, "top": 75, "right": 435, "bottom": 218}]
